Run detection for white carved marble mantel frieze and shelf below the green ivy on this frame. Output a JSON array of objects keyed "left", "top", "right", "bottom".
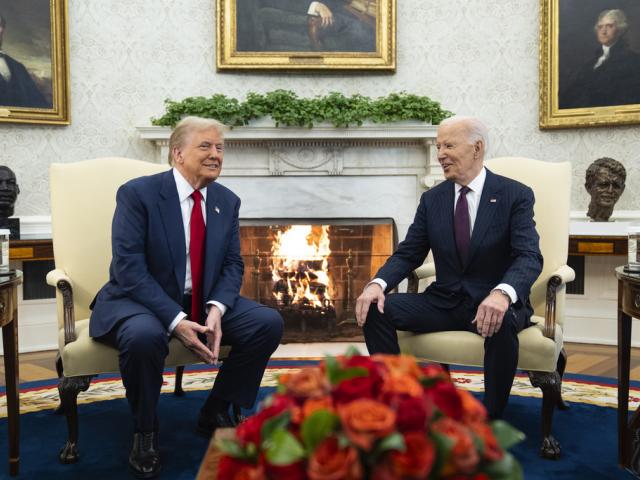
[{"left": 137, "top": 120, "right": 442, "bottom": 189}]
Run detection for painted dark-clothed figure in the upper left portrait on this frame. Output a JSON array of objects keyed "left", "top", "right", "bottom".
[{"left": 0, "top": 14, "right": 51, "bottom": 108}]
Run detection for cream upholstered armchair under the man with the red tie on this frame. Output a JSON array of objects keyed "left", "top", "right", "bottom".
[{"left": 47, "top": 158, "right": 228, "bottom": 463}]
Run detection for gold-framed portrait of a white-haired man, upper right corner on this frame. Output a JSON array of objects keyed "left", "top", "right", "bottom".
[{"left": 540, "top": 0, "right": 640, "bottom": 129}]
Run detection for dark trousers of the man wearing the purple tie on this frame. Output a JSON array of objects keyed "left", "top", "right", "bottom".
[{"left": 363, "top": 293, "right": 529, "bottom": 418}]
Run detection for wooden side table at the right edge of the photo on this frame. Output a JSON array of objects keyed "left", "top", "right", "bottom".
[{"left": 616, "top": 267, "right": 640, "bottom": 474}]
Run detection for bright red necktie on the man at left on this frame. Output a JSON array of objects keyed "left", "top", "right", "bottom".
[{"left": 189, "top": 190, "right": 205, "bottom": 323}]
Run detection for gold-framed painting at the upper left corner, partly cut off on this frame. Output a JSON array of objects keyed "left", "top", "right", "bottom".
[{"left": 0, "top": 0, "right": 69, "bottom": 125}]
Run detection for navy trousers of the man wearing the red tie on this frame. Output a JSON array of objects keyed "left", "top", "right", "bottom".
[{"left": 97, "top": 298, "right": 283, "bottom": 432}]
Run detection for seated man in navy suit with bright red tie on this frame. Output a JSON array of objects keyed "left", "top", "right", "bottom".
[{"left": 90, "top": 117, "right": 283, "bottom": 478}]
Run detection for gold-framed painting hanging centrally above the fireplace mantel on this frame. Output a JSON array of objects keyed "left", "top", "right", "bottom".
[{"left": 216, "top": 0, "right": 396, "bottom": 71}]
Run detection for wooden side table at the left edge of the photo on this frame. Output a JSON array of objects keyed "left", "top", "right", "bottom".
[{"left": 0, "top": 270, "right": 22, "bottom": 475}]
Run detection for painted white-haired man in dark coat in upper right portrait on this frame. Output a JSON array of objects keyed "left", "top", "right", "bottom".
[{"left": 559, "top": 9, "right": 640, "bottom": 108}]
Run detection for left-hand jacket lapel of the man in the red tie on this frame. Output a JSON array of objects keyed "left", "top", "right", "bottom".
[{"left": 158, "top": 170, "right": 187, "bottom": 292}]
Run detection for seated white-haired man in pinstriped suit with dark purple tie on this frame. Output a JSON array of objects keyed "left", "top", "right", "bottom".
[{"left": 356, "top": 117, "right": 542, "bottom": 418}]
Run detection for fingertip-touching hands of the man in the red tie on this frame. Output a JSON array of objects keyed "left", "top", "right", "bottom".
[{"left": 173, "top": 305, "right": 222, "bottom": 365}]
